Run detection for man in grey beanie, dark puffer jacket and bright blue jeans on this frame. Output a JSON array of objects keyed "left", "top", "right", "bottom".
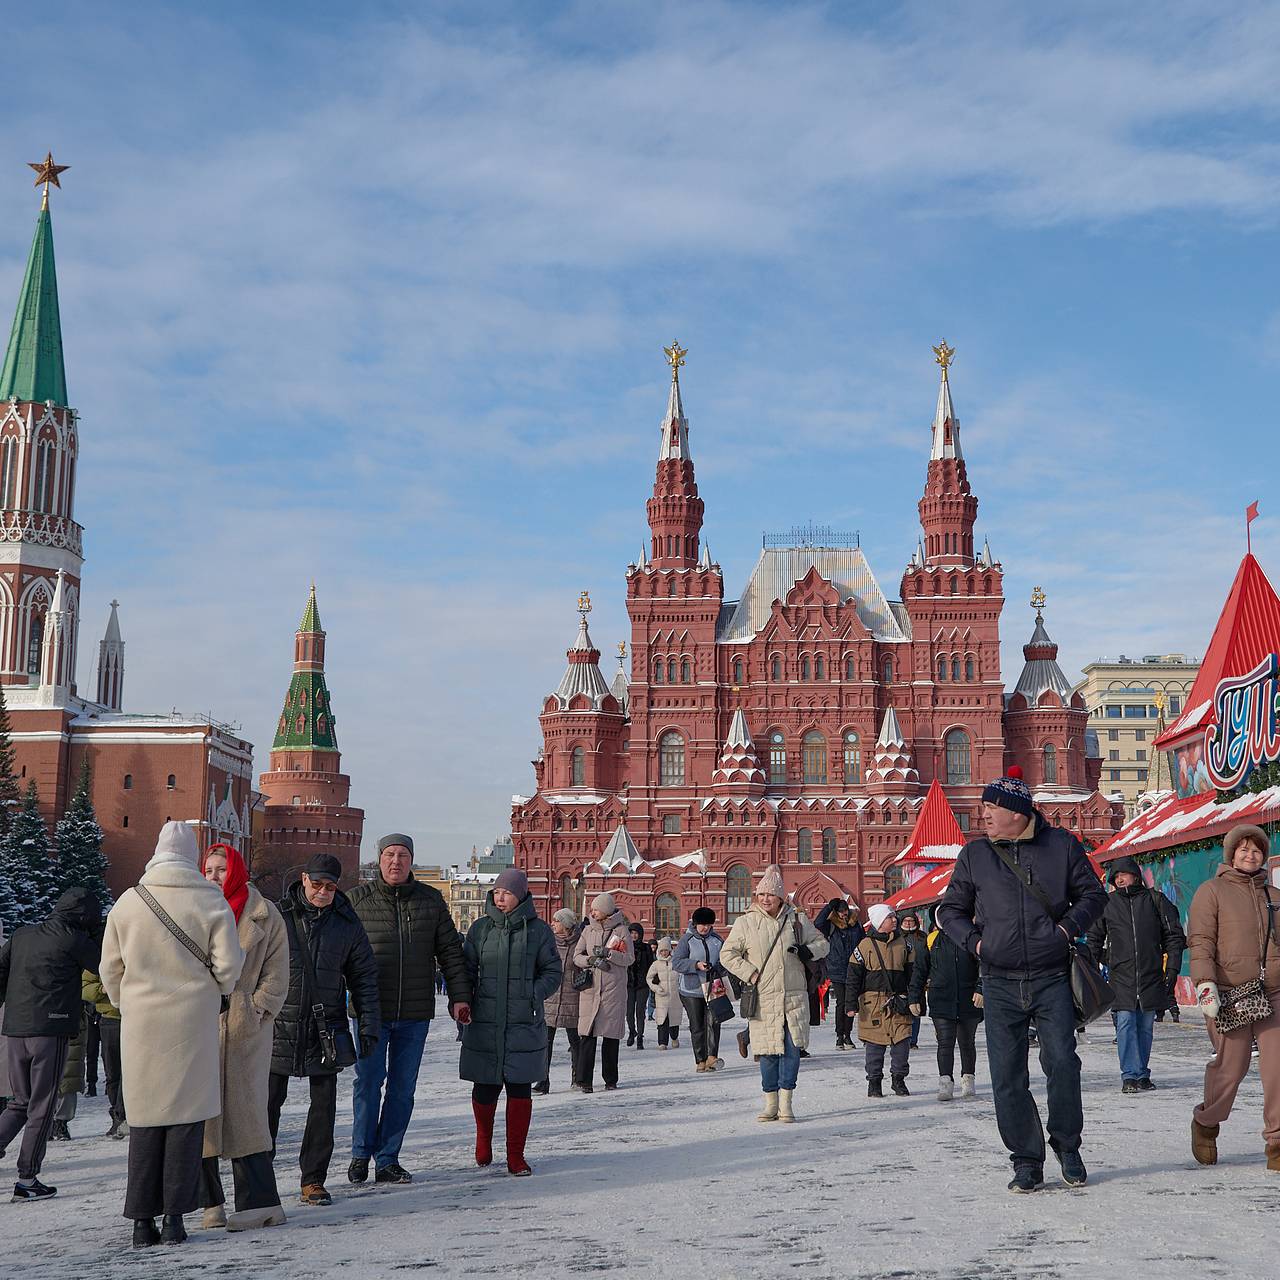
[{"left": 347, "top": 832, "right": 471, "bottom": 1183}]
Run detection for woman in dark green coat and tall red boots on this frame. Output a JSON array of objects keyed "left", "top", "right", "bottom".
[{"left": 458, "top": 867, "right": 563, "bottom": 1178}]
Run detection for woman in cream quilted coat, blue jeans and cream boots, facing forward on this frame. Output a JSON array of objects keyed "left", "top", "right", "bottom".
[{"left": 721, "top": 867, "right": 827, "bottom": 1121}]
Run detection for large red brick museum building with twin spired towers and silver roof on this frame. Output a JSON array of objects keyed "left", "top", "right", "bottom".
[{"left": 512, "top": 344, "right": 1121, "bottom": 933}]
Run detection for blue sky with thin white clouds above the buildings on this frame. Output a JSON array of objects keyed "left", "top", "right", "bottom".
[{"left": 0, "top": 3, "right": 1280, "bottom": 861}]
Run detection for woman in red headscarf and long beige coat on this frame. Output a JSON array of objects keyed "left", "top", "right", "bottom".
[{"left": 201, "top": 845, "right": 289, "bottom": 1231}]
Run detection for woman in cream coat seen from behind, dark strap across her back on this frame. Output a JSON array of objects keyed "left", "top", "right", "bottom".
[{"left": 100, "top": 822, "right": 244, "bottom": 1247}]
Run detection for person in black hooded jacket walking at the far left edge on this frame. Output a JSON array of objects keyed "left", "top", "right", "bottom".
[{"left": 0, "top": 888, "right": 102, "bottom": 1201}]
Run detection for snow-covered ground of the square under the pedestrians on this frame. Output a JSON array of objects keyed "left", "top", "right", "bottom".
[{"left": 0, "top": 1014, "right": 1280, "bottom": 1280}]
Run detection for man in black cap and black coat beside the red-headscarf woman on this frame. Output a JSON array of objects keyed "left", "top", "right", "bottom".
[{"left": 268, "top": 854, "right": 381, "bottom": 1204}]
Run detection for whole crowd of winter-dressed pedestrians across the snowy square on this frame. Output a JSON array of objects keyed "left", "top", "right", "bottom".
[{"left": 0, "top": 777, "right": 1280, "bottom": 1248}]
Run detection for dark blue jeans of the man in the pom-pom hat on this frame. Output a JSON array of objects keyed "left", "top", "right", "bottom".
[{"left": 982, "top": 973, "right": 1084, "bottom": 1169}]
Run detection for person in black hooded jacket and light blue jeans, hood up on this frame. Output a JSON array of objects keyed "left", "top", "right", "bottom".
[{"left": 1089, "top": 858, "right": 1187, "bottom": 1093}]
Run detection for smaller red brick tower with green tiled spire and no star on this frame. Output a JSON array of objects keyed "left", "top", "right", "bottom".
[{"left": 253, "top": 585, "right": 365, "bottom": 884}]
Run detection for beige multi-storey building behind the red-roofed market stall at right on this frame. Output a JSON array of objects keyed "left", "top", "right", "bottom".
[{"left": 1075, "top": 653, "right": 1199, "bottom": 822}]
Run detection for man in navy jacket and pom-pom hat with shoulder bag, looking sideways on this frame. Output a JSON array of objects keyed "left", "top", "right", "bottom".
[{"left": 938, "top": 773, "right": 1106, "bottom": 1192}]
